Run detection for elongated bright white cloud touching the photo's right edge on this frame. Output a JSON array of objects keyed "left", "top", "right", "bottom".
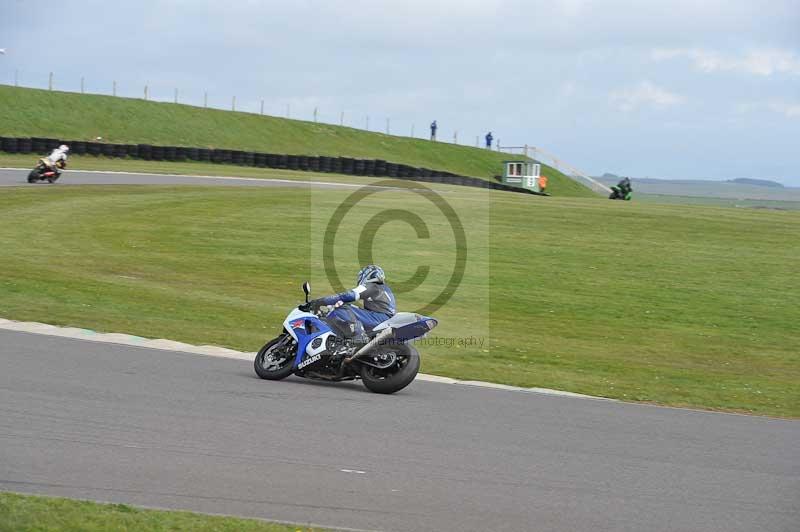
[{"left": 651, "top": 48, "right": 800, "bottom": 76}]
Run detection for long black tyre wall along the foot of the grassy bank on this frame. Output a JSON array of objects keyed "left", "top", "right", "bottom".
[{"left": 0, "top": 137, "right": 542, "bottom": 195}]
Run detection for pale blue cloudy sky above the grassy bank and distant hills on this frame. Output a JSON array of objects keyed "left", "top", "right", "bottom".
[{"left": 0, "top": 0, "right": 800, "bottom": 186}]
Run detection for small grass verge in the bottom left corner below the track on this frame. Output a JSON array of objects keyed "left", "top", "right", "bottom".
[{"left": 0, "top": 492, "right": 322, "bottom": 532}]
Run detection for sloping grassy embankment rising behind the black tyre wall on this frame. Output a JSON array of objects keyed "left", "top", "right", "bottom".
[{"left": 0, "top": 85, "right": 594, "bottom": 197}]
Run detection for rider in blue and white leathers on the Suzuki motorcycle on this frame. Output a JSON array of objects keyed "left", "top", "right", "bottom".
[{"left": 308, "top": 264, "right": 397, "bottom": 341}]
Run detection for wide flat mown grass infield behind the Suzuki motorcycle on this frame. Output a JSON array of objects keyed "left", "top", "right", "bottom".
[{"left": 0, "top": 177, "right": 800, "bottom": 417}]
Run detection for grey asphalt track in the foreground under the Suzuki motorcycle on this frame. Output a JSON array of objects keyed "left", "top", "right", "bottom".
[{"left": 0, "top": 331, "right": 800, "bottom": 532}]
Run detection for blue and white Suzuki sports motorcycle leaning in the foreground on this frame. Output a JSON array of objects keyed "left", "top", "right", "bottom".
[{"left": 254, "top": 282, "right": 439, "bottom": 394}]
